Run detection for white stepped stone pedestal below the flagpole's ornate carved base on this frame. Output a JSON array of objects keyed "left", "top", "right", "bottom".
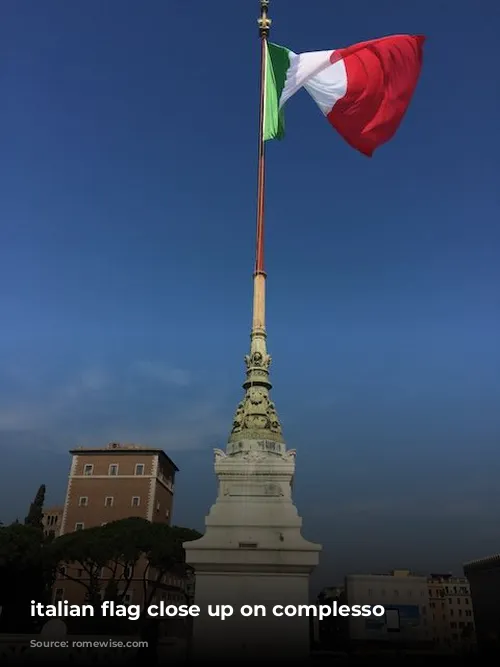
[{"left": 184, "top": 440, "right": 321, "bottom": 662}]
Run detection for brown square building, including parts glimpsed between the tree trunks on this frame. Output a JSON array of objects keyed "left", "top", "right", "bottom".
[{"left": 52, "top": 443, "right": 186, "bottom": 616}]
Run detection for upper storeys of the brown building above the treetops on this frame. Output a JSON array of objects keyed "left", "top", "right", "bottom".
[{"left": 60, "top": 443, "right": 178, "bottom": 535}]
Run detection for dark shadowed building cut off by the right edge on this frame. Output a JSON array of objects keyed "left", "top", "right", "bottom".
[{"left": 464, "top": 554, "right": 500, "bottom": 654}]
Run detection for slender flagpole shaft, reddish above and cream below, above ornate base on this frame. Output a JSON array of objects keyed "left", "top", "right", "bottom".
[{"left": 252, "top": 0, "right": 271, "bottom": 334}]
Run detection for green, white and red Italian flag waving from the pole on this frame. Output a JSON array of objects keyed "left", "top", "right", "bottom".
[{"left": 263, "top": 35, "right": 425, "bottom": 157}]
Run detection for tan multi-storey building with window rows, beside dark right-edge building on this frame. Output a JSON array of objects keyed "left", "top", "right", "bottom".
[{"left": 428, "top": 574, "right": 476, "bottom": 653}]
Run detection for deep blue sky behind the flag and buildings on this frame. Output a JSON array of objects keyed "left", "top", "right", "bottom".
[{"left": 0, "top": 0, "right": 500, "bottom": 581}]
